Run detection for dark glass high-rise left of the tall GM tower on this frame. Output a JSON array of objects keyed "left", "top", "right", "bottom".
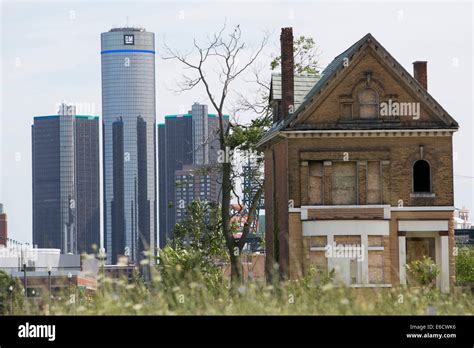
[{"left": 32, "top": 104, "right": 100, "bottom": 254}]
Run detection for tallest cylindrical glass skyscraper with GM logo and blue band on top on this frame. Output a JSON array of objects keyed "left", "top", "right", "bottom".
[{"left": 101, "top": 28, "right": 157, "bottom": 263}]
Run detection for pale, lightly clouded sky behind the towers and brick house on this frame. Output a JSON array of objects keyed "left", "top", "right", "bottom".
[{"left": 0, "top": 0, "right": 474, "bottom": 243}]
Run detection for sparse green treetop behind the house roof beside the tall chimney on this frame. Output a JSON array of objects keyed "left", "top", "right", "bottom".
[{"left": 270, "top": 36, "right": 319, "bottom": 75}]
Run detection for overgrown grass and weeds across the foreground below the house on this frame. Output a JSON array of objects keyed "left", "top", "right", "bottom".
[{"left": 7, "top": 267, "right": 474, "bottom": 315}]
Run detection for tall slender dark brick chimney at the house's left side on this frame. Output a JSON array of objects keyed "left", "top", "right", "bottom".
[{"left": 280, "top": 27, "right": 295, "bottom": 120}]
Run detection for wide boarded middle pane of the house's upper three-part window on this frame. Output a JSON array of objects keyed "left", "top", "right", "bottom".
[{"left": 332, "top": 162, "right": 356, "bottom": 205}]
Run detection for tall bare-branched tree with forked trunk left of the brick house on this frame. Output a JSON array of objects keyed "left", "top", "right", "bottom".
[{"left": 164, "top": 25, "right": 268, "bottom": 281}]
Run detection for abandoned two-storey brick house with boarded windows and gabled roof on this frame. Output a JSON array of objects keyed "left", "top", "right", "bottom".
[{"left": 259, "top": 28, "right": 458, "bottom": 291}]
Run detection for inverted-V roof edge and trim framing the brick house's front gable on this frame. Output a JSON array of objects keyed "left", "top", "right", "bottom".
[{"left": 259, "top": 33, "right": 459, "bottom": 145}]
